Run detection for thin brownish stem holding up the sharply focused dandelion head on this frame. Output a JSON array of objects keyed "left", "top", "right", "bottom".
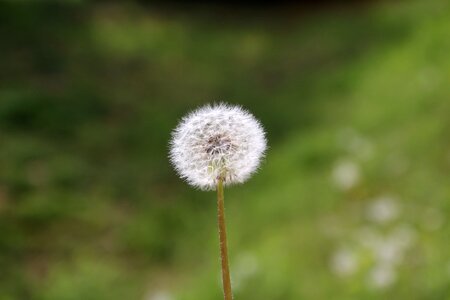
[{"left": 217, "top": 178, "right": 233, "bottom": 300}]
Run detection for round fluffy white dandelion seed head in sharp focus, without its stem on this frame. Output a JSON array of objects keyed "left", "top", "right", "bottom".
[{"left": 170, "top": 104, "right": 267, "bottom": 190}]
